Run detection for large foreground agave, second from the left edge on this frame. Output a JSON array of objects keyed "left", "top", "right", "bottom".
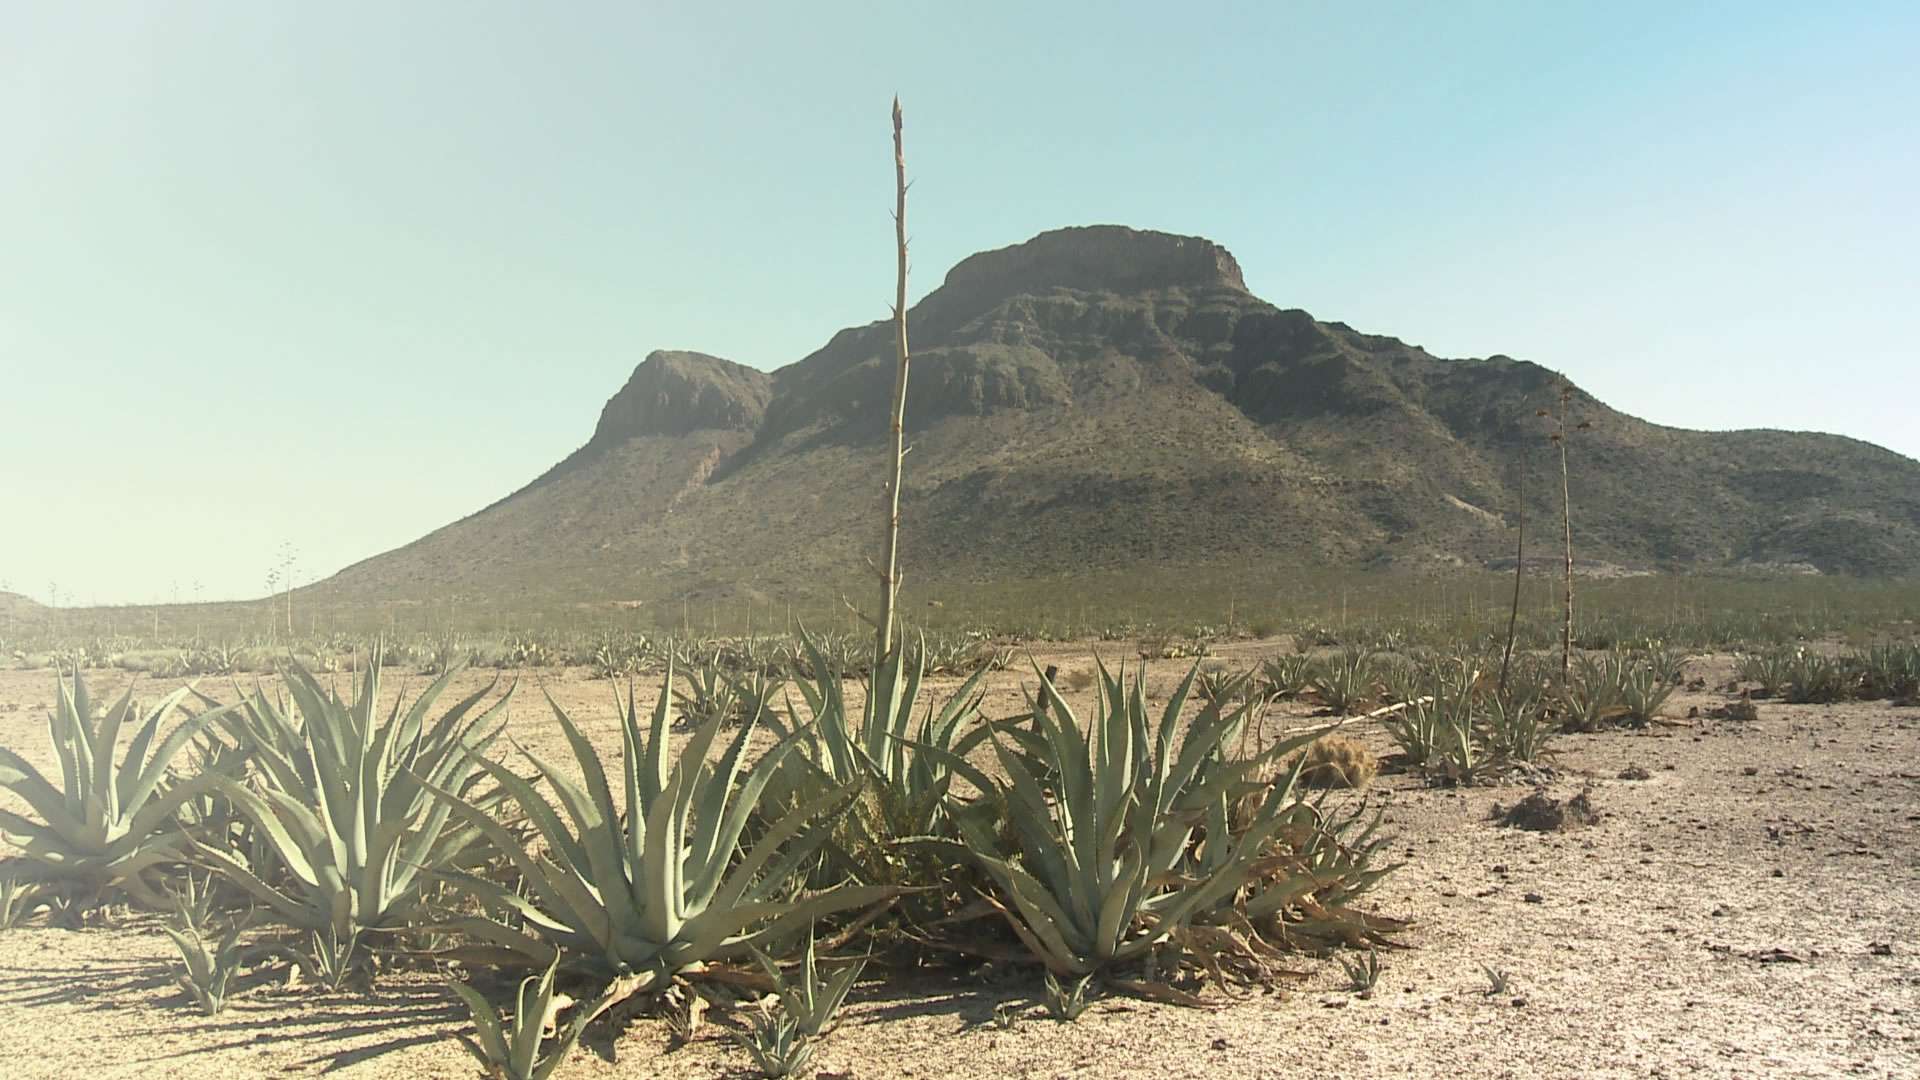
[{"left": 196, "top": 646, "right": 513, "bottom": 949}]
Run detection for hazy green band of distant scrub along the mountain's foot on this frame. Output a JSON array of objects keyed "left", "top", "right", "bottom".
[{"left": 15, "top": 567, "right": 1920, "bottom": 671}]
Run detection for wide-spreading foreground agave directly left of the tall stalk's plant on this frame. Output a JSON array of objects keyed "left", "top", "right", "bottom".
[{"left": 428, "top": 669, "right": 895, "bottom": 980}]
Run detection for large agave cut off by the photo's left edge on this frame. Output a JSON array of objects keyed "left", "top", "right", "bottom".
[{"left": 0, "top": 671, "right": 238, "bottom": 907}]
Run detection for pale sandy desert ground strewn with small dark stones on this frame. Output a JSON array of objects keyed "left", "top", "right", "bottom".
[{"left": 0, "top": 644, "right": 1920, "bottom": 1080}]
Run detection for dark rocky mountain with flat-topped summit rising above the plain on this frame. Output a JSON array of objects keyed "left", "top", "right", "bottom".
[{"left": 319, "top": 225, "right": 1920, "bottom": 600}]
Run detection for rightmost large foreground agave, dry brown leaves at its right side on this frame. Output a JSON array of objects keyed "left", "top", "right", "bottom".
[{"left": 935, "top": 665, "right": 1323, "bottom": 978}]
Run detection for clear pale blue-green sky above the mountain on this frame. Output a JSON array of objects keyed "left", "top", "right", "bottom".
[{"left": 0, "top": 0, "right": 1920, "bottom": 605}]
